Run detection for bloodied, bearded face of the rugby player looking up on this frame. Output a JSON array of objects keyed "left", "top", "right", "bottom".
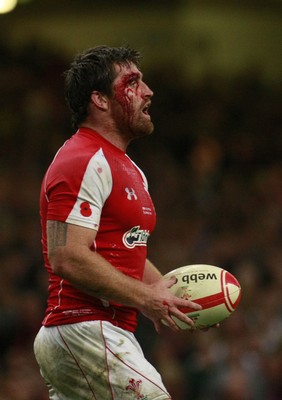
[{"left": 112, "top": 63, "right": 154, "bottom": 139}]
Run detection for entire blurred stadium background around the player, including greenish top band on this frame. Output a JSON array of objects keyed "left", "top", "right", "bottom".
[{"left": 0, "top": 0, "right": 282, "bottom": 400}]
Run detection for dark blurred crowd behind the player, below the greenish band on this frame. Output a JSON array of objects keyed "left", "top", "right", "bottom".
[{"left": 0, "top": 44, "right": 282, "bottom": 400}]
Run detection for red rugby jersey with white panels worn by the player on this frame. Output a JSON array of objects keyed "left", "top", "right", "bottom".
[{"left": 40, "top": 128, "right": 156, "bottom": 332}]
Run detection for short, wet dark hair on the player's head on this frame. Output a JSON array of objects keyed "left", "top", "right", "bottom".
[{"left": 64, "top": 46, "right": 140, "bottom": 128}]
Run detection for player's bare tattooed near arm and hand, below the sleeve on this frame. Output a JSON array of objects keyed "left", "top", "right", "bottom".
[{"left": 47, "top": 221, "right": 199, "bottom": 331}]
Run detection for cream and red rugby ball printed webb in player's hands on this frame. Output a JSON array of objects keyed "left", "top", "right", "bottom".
[{"left": 164, "top": 264, "right": 241, "bottom": 330}]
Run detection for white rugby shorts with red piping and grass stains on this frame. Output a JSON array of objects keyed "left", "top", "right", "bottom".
[{"left": 34, "top": 321, "right": 171, "bottom": 400}]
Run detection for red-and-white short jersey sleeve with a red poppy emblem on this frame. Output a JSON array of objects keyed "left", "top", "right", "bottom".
[{"left": 44, "top": 149, "right": 112, "bottom": 230}]
